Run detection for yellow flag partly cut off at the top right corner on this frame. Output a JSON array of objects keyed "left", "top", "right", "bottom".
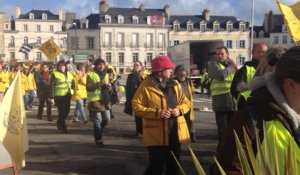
[{"left": 278, "top": 1, "right": 300, "bottom": 42}]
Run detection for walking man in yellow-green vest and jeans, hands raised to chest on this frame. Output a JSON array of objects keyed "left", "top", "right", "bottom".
[{"left": 86, "top": 58, "right": 110, "bottom": 148}]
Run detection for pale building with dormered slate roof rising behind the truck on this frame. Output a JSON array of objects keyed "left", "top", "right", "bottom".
[{"left": 169, "top": 9, "right": 250, "bottom": 66}]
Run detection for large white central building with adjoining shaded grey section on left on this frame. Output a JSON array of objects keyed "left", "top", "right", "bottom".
[{"left": 68, "top": 1, "right": 170, "bottom": 74}]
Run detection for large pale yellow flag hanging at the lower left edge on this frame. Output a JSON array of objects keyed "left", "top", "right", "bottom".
[{"left": 0, "top": 72, "right": 28, "bottom": 169}]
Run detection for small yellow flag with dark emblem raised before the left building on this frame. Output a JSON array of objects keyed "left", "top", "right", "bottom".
[{"left": 39, "top": 39, "right": 61, "bottom": 60}]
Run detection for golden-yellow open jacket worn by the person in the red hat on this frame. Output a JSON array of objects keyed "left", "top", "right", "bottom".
[{"left": 132, "top": 77, "right": 191, "bottom": 146}]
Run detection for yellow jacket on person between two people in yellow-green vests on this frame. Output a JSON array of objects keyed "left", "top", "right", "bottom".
[{"left": 73, "top": 73, "right": 87, "bottom": 100}]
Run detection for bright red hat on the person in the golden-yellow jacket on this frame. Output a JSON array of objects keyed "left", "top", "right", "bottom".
[{"left": 151, "top": 56, "right": 175, "bottom": 72}]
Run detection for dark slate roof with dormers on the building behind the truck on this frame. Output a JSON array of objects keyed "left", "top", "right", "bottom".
[{"left": 170, "top": 15, "right": 248, "bottom": 30}]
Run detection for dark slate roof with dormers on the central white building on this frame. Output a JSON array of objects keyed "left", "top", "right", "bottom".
[{"left": 100, "top": 8, "right": 168, "bottom": 24}]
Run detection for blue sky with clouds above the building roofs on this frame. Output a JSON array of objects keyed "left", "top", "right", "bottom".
[{"left": 0, "top": 0, "right": 298, "bottom": 25}]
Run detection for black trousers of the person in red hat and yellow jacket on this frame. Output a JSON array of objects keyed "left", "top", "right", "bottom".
[{"left": 144, "top": 143, "right": 181, "bottom": 175}]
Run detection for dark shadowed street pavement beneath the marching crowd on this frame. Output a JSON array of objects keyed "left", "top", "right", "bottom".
[{"left": 2, "top": 95, "right": 217, "bottom": 175}]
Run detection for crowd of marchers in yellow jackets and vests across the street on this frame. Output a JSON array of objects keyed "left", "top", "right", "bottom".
[{"left": 0, "top": 43, "right": 300, "bottom": 175}]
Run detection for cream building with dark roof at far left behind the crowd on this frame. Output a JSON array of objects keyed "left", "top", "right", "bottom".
[{"left": 4, "top": 7, "right": 67, "bottom": 61}]
